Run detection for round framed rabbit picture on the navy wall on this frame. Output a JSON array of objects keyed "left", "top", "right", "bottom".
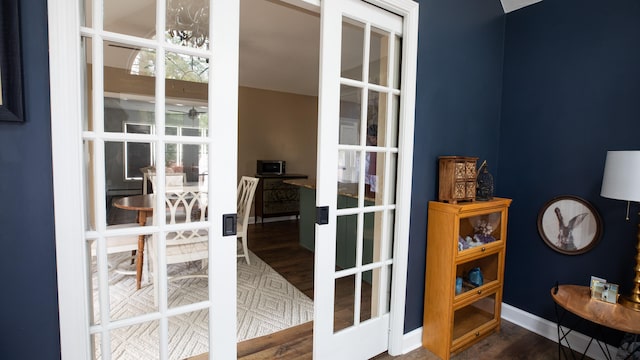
[{"left": 538, "top": 195, "right": 602, "bottom": 255}]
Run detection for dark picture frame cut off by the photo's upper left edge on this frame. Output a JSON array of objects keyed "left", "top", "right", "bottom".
[{"left": 0, "top": 0, "right": 24, "bottom": 122}]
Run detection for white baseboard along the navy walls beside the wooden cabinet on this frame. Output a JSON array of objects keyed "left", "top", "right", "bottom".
[{"left": 402, "top": 303, "right": 618, "bottom": 360}]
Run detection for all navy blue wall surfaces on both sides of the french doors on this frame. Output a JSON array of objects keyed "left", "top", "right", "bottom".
[{"left": 10, "top": 0, "right": 640, "bottom": 359}]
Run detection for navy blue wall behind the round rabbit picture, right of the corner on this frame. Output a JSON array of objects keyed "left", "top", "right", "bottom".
[{"left": 498, "top": 0, "right": 640, "bottom": 340}]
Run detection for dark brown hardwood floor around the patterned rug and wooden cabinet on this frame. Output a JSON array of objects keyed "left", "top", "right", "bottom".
[{"left": 228, "top": 221, "right": 588, "bottom": 360}]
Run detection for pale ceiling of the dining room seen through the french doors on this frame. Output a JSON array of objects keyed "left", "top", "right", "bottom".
[{"left": 100, "top": 0, "right": 320, "bottom": 95}]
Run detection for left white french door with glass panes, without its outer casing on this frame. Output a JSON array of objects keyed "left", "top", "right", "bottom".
[{"left": 79, "top": 0, "right": 239, "bottom": 359}]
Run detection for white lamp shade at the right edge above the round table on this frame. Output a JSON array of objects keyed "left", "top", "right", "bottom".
[{"left": 600, "top": 150, "right": 640, "bottom": 202}]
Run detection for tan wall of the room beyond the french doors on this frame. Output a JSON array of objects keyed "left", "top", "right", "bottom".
[{"left": 100, "top": 64, "right": 318, "bottom": 184}]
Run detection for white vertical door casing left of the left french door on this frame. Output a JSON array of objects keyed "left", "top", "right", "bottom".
[{"left": 48, "top": 1, "right": 91, "bottom": 359}]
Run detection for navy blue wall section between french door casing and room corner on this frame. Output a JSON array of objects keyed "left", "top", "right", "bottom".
[{"left": 405, "top": 0, "right": 509, "bottom": 332}]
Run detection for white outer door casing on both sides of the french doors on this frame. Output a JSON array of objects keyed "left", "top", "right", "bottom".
[{"left": 48, "top": 0, "right": 419, "bottom": 359}]
